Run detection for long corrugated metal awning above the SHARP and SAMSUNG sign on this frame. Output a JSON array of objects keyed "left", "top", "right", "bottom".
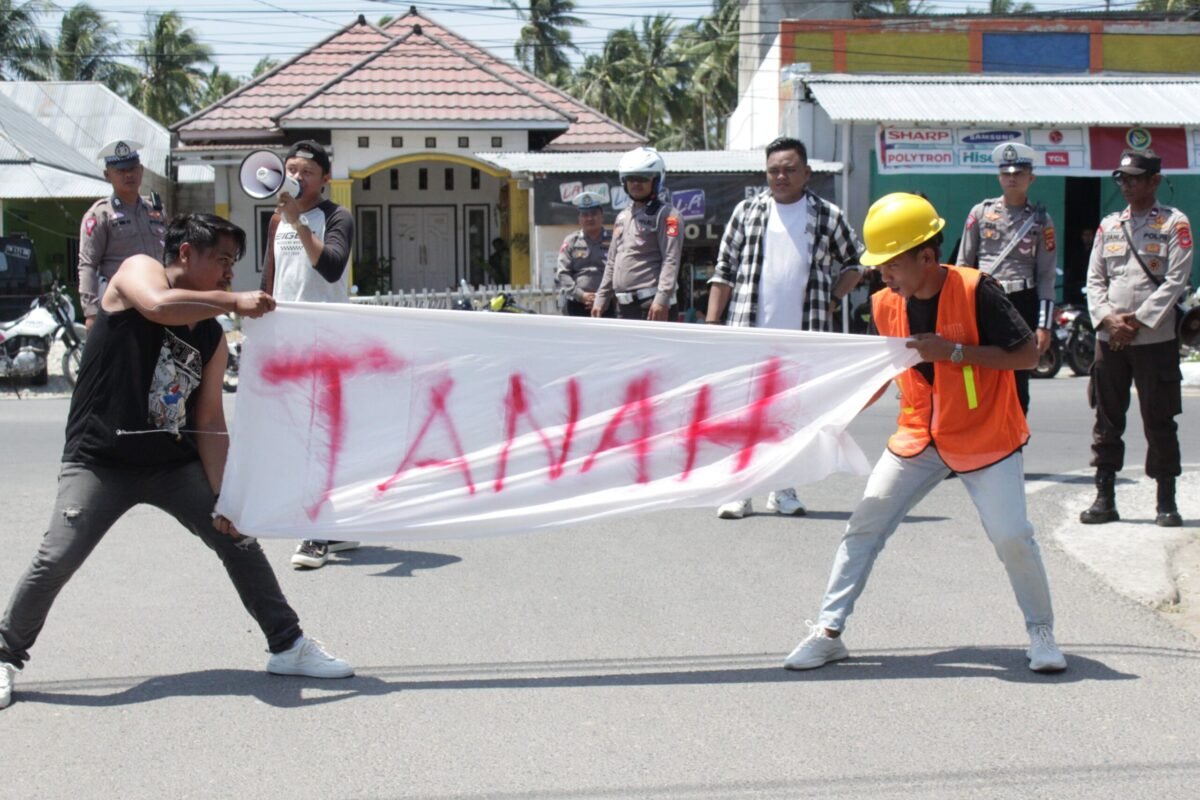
[{"left": 797, "top": 74, "right": 1200, "bottom": 126}]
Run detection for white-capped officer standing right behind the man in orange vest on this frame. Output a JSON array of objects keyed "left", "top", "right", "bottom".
[{"left": 958, "top": 142, "right": 1058, "bottom": 415}]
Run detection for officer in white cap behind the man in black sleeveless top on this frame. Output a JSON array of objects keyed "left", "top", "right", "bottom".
[{"left": 79, "top": 140, "right": 167, "bottom": 330}]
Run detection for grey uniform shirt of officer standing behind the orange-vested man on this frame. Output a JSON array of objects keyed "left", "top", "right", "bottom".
[{"left": 958, "top": 197, "right": 1058, "bottom": 302}]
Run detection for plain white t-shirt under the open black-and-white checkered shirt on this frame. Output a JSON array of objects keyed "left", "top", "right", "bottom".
[{"left": 755, "top": 197, "right": 810, "bottom": 331}]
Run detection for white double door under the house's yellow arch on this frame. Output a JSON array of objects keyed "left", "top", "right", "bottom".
[{"left": 391, "top": 205, "right": 458, "bottom": 290}]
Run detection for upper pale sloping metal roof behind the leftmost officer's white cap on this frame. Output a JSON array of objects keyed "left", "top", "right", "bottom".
[{"left": 0, "top": 80, "right": 170, "bottom": 178}]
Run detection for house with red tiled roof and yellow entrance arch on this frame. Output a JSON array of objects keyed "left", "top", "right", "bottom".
[{"left": 173, "top": 7, "right": 644, "bottom": 289}]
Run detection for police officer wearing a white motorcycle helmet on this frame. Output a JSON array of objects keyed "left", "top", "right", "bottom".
[{"left": 592, "top": 148, "right": 683, "bottom": 321}]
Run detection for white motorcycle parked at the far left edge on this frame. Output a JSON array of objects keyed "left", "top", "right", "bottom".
[{"left": 0, "top": 283, "right": 88, "bottom": 386}]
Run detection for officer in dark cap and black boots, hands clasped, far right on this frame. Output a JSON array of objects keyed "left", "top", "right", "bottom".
[{"left": 1080, "top": 150, "right": 1193, "bottom": 528}]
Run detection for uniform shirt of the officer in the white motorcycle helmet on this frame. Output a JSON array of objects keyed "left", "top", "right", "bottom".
[{"left": 596, "top": 198, "right": 684, "bottom": 307}]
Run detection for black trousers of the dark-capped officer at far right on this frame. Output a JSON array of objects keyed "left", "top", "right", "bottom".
[{"left": 1087, "top": 339, "right": 1183, "bottom": 479}]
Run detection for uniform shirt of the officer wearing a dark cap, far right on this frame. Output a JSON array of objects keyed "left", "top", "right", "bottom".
[{"left": 1087, "top": 204, "right": 1193, "bottom": 345}]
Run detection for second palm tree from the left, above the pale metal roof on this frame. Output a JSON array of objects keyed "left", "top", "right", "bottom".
[{"left": 54, "top": 2, "right": 138, "bottom": 95}]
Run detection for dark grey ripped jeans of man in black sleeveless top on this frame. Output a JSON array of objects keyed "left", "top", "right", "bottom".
[{"left": 0, "top": 461, "right": 301, "bottom": 667}]
